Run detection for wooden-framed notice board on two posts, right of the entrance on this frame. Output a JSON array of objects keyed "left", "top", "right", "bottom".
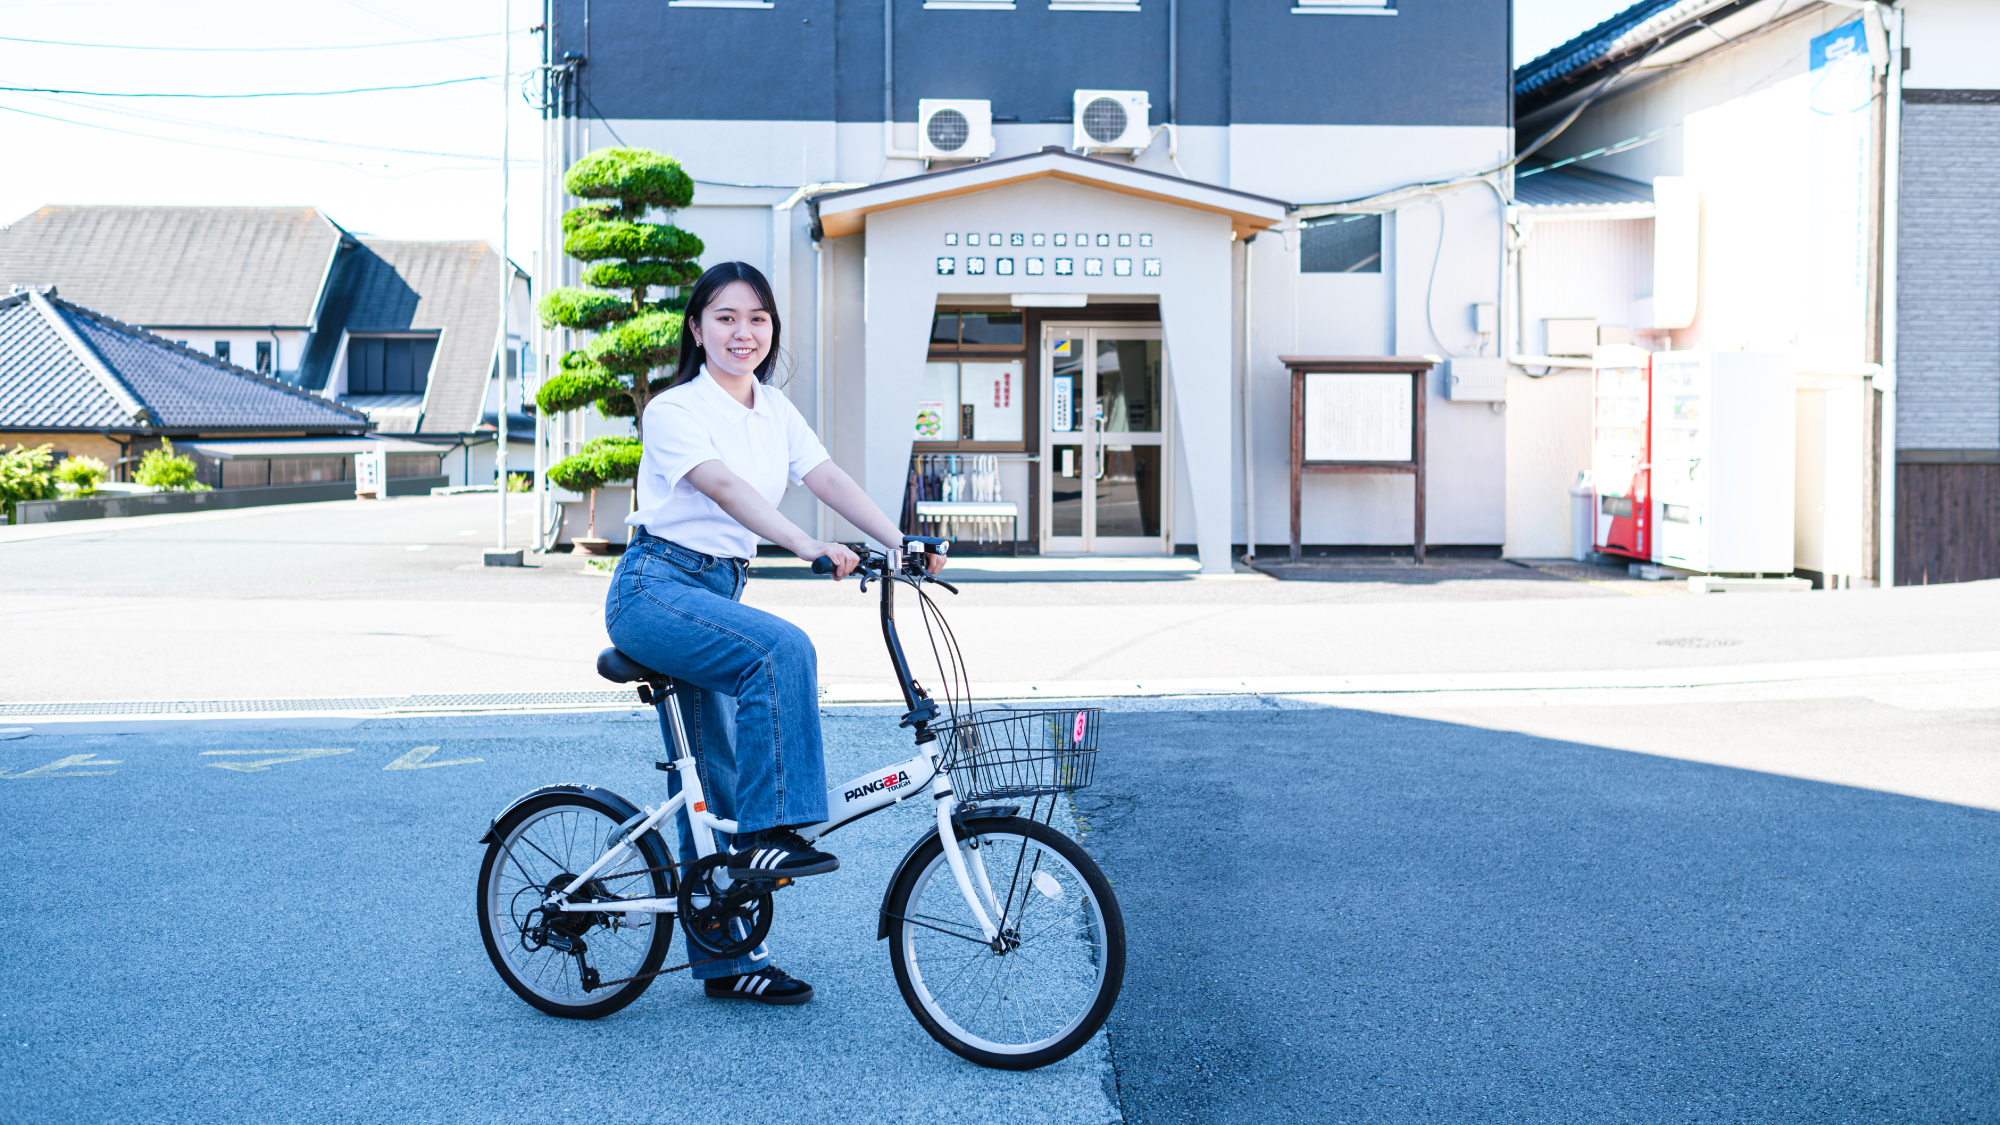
[{"left": 1278, "top": 356, "right": 1438, "bottom": 567}]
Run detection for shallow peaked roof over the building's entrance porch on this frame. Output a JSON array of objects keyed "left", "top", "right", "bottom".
[{"left": 810, "top": 146, "right": 1288, "bottom": 238}]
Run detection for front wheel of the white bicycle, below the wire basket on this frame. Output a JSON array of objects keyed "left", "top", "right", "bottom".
[{"left": 888, "top": 817, "right": 1124, "bottom": 1071}]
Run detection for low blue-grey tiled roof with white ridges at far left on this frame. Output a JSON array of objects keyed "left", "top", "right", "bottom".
[{"left": 0, "top": 290, "right": 368, "bottom": 432}]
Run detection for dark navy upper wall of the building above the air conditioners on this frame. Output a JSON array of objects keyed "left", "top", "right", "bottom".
[{"left": 550, "top": 0, "right": 1512, "bottom": 126}]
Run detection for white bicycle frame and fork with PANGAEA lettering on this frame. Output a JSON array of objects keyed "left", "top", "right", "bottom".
[{"left": 542, "top": 691, "right": 1004, "bottom": 943}]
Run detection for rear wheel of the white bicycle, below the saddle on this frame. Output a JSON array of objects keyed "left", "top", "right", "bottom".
[{"left": 478, "top": 793, "right": 674, "bottom": 1019}]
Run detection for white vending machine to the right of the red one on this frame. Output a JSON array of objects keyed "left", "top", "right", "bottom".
[{"left": 1652, "top": 350, "right": 1798, "bottom": 575}]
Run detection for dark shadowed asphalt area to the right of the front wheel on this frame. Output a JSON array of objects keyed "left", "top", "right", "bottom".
[{"left": 1076, "top": 709, "right": 2000, "bottom": 1125}]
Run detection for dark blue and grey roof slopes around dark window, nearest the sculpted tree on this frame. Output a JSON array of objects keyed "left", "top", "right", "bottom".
[{"left": 304, "top": 238, "right": 518, "bottom": 434}]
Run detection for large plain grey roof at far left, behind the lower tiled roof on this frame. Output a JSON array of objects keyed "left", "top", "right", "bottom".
[{"left": 0, "top": 206, "right": 352, "bottom": 328}]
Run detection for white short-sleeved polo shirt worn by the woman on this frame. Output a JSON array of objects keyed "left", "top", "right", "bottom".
[{"left": 626, "top": 366, "right": 826, "bottom": 558}]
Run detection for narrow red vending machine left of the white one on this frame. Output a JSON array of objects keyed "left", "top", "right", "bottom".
[{"left": 1590, "top": 344, "right": 1658, "bottom": 560}]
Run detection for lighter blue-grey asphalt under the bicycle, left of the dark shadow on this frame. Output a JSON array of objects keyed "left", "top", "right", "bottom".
[{"left": 0, "top": 713, "right": 1116, "bottom": 1125}]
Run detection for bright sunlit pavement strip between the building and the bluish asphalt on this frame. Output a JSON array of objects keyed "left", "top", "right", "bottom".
[{"left": 0, "top": 494, "right": 2000, "bottom": 701}]
